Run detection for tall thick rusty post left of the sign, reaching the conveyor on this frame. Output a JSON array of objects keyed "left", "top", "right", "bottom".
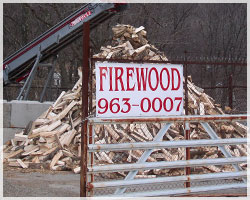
[{"left": 80, "top": 22, "right": 90, "bottom": 197}]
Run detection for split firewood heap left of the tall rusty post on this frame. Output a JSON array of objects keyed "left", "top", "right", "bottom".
[{"left": 4, "top": 68, "right": 82, "bottom": 173}]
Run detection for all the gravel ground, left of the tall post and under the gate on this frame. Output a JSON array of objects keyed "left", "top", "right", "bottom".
[{"left": 3, "top": 167, "right": 247, "bottom": 197}]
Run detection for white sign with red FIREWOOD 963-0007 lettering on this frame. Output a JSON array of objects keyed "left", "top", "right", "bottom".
[{"left": 95, "top": 62, "right": 183, "bottom": 118}]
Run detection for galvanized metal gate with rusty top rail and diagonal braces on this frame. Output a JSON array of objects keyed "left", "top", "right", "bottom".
[{"left": 87, "top": 115, "right": 247, "bottom": 197}]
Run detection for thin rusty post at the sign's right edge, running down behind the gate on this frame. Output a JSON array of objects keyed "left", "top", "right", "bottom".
[{"left": 184, "top": 51, "right": 191, "bottom": 188}]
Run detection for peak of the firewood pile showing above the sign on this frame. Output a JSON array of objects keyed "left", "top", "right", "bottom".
[{"left": 93, "top": 25, "right": 168, "bottom": 61}]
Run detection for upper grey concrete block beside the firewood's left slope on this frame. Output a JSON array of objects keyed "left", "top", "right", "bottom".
[{"left": 10, "top": 100, "right": 52, "bottom": 128}]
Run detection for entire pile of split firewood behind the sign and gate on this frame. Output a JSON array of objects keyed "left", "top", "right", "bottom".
[{"left": 3, "top": 25, "right": 247, "bottom": 177}]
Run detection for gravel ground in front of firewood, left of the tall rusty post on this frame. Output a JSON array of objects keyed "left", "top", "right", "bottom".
[{"left": 3, "top": 167, "right": 80, "bottom": 197}]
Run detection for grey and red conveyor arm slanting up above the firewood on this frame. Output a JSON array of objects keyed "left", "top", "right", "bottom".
[{"left": 3, "top": 3, "right": 126, "bottom": 85}]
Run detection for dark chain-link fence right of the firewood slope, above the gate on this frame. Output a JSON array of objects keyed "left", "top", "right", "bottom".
[{"left": 182, "top": 58, "right": 247, "bottom": 114}]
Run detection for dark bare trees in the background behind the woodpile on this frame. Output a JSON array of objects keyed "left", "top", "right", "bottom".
[{"left": 3, "top": 3, "right": 247, "bottom": 106}]
